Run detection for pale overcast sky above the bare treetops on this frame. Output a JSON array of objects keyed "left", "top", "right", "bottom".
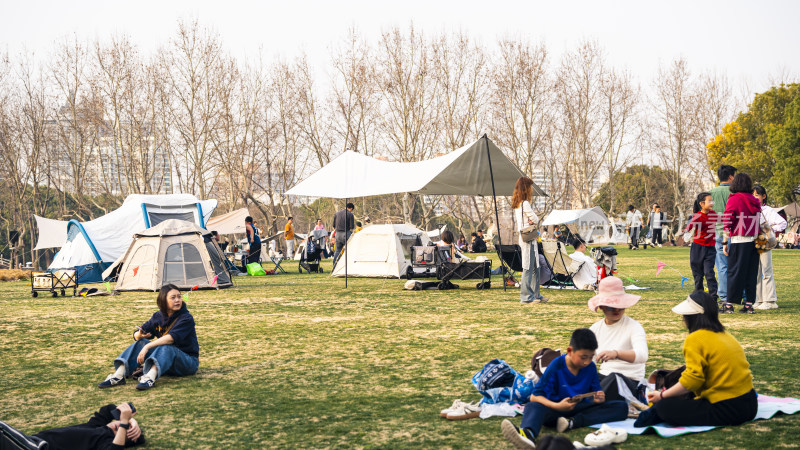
[{"left": 0, "top": 0, "right": 800, "bottom": 97}]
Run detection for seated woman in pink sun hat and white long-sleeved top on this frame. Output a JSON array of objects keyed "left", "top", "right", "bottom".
[{"left": 589, "top": 276, "right": 648, "bottom": 401}]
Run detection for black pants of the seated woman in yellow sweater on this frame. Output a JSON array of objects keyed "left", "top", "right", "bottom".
[{"left": 635, "top": 390, "right": 758, "bottom": 427}]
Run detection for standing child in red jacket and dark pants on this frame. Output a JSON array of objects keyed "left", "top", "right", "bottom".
[{"left": 685, "top": 192, "right": 720, "bottom": 304}]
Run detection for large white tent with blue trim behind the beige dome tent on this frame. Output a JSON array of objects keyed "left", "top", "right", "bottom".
[{"left": 48, "top": 194, "right": 217, "bottom": 283}]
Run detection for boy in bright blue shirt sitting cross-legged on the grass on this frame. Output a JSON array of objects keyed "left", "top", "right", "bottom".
[{"left": 501, "top": 328, "right": 628, "bottom": 448}]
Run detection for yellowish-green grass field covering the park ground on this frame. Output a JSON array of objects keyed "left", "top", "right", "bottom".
[{"left": 0, "top": 248, "right": 800, "bottom": 449}]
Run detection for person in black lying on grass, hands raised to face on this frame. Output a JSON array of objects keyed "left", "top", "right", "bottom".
[{"left": 21, "top": 403, "right": 145, "bottom": 450}]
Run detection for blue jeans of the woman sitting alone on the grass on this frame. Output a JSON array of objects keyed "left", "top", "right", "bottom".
[{"left": 114, "top": 339, "right": 200, "bottom": 378}]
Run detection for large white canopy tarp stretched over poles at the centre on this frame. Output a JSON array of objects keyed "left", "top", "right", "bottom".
[{"left": 286, "top": 137, "right": 547, "bottom": 198}]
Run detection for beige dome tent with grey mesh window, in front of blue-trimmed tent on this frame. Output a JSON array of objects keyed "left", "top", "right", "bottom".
[{"left": 103, "top": 219, "right": 233, "bottom": 291}]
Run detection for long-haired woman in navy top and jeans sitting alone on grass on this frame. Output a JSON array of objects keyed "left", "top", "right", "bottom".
[{"left": 98, "top": 284, "right": 200, "bottom": 391}]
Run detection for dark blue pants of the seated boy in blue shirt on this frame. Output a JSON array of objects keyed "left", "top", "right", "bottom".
[{"left": 520, "top": 400, "right": 628, "bottom": 436}]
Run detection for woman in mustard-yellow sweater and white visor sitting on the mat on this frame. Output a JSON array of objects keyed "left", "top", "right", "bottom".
[{"left": 636, "top": 291, "right": 758, "bottom": 426}]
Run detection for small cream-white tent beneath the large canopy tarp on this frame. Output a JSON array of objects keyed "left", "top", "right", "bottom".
[{"left": 331, "top": 224, "right": 430, "bottom": 278}]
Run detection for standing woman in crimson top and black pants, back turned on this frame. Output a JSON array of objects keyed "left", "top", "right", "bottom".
[{"left": 722, "top": 173, "right": 761, "bottom": 314}]
